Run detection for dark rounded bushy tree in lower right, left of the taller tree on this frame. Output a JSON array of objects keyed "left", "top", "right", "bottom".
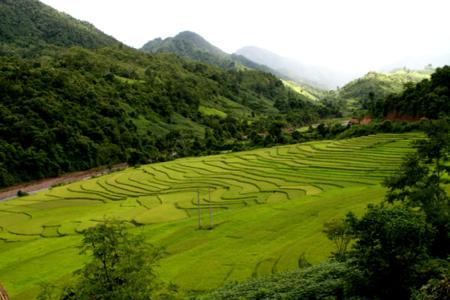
[{"left": 347, "top": 205, "right": 434, "bottom": 299}]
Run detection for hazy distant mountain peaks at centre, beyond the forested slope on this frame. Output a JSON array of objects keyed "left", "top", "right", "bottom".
[{"left": 140, "top": 31, "right": 362, "bottom": 90}]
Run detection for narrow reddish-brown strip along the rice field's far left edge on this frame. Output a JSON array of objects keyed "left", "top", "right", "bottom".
[{"left": 0, "top": 164, "right": 128, "bottom": 201}]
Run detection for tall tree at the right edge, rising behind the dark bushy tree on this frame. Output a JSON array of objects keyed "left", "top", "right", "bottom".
[{"left": 384, "top": 120, "right": 450, "bottom": 259}]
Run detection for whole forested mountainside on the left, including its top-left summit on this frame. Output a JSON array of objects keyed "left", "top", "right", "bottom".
[{"left": 0, "top": 0, "right": 327, "bottom": 187}]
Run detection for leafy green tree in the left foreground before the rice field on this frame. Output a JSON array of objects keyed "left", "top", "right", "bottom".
[{"left": 58, "top": 220, "right": 162, "bottom": 300}]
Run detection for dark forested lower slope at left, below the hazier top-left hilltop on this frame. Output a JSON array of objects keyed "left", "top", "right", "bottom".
[{"left": 0, "top": 47, "right": 315, "bottom": 186}]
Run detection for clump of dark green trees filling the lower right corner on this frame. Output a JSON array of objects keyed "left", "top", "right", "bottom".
[{"left": 347, "top": 120, "right": 450, "bottom": 299}]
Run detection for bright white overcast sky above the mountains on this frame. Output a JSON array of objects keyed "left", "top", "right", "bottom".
[{"left": 42, "top": 0, "right": 450, "bottom": 72}]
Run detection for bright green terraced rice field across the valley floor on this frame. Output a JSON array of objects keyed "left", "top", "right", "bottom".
[{"left": 0, "top": 134, "right": 420, "bottom": 299}]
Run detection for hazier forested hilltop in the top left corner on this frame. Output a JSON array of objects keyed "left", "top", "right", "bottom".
[{"left": 0, "top": 0, "right": 119, "bottom": 48}]
